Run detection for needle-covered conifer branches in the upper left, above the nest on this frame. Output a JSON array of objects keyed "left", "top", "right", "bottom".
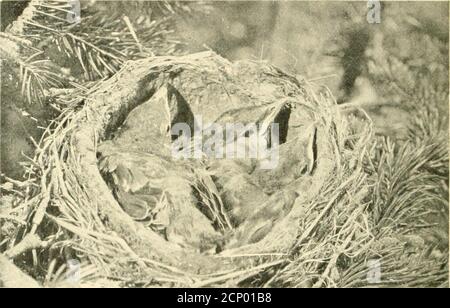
[{"left": 0, "top": 0, "right": 195, "bottom": 103}]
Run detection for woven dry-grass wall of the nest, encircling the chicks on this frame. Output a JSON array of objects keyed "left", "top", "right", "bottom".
[{"left": 1, "top": 52, "right": 448, "bottom": 287}]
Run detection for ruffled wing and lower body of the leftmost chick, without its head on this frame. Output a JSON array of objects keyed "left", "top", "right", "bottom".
[{"left": 98, "top": 141, "right": 221, "bottom": 251}]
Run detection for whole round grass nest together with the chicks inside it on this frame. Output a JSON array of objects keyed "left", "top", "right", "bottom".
[{"left": 9, "top": 52, "right": 372, "bottom": 287}]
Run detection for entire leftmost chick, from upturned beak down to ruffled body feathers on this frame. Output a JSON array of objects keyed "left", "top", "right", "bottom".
[{"left": 98, "top": 86, "right": 221, "bottom": 250}]
